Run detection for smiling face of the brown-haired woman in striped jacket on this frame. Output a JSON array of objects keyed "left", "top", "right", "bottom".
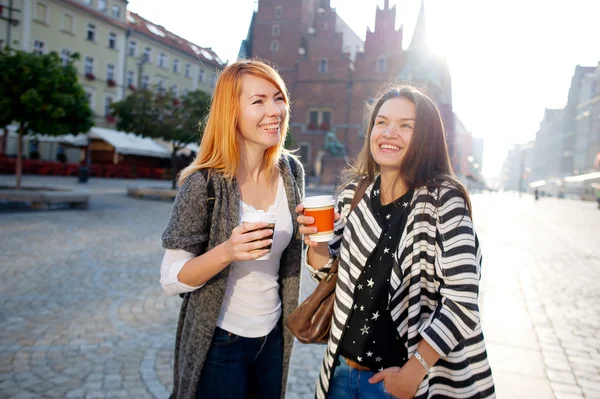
[{"left": 370, "top": 97, "right": 417, "bottom": 173}]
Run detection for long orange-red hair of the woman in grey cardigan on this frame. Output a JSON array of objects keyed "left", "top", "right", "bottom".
[{"left": 179, "top": 59, "right": 290, "bottom": 184}]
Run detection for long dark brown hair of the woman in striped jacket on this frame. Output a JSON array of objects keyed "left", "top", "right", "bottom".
[{"left": 343, "top": 86, "right": 471, "bottom": 219}]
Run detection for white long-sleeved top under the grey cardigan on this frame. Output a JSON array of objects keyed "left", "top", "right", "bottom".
[{"left": 160, "top": 176, "right": 293, "bottom": 338}]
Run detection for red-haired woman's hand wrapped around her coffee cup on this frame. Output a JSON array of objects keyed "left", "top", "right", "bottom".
[{"left": 225, "top": 222, "right": 273, "bottom": 263}]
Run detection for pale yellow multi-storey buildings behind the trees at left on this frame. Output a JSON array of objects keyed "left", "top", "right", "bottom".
[{"left": 0, "top": 0, "right": 225, "bottom": 126}]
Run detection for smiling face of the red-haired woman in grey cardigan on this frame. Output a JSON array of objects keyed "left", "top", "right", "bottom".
[{"left": 237, "top": 74, "right": 288, "bottom": 151}]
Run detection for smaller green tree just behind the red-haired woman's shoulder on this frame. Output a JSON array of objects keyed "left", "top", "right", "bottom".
[{"left": 112, "top": 90, "right": 211, "bottom": 188}]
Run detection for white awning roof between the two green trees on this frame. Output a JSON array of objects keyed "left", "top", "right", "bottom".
[{"left": 89, "top": 127, "right": 171, "bottom": 158}]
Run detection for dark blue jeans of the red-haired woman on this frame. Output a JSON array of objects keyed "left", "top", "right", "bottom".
[{"left": 196, "top": 326, "right": 283, "bottom": 399}]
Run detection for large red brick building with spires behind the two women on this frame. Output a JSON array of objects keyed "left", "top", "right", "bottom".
[{"left": 240, "top": 0, "right": 454, "bottom": 175}]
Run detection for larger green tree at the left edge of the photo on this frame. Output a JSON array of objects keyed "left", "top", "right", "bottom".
[{"left": 0, "top": 48, "right": 93, "bottom": 189}]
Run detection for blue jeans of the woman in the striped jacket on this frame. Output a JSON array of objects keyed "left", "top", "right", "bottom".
[{"left": 327, "top": 356, "right": 398, "bottom": 399}]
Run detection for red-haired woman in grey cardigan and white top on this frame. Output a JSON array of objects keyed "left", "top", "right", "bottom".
[{"left": 160, "top": 60, "right": 304, "bottom": 399}]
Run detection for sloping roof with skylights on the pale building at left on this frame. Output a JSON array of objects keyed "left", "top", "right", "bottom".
[{"left": 127, "top": 11, "right": 226, "bottom": 68}]
